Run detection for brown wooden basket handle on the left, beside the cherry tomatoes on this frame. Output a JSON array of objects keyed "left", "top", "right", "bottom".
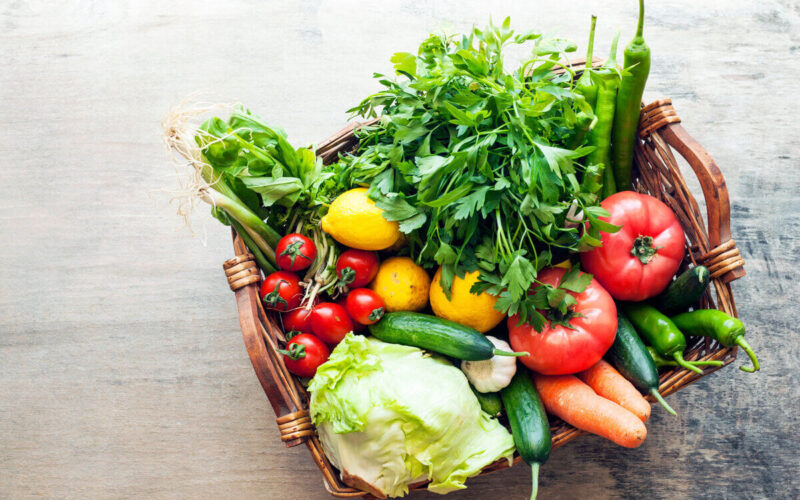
[{"left": 222, "top": 231, "right": 314, "bottom": 447}]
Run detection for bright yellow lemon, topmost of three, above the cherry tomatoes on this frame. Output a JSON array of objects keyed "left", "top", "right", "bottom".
[{"left": 321, "top": 188, "right": 402, "bottom": 250}]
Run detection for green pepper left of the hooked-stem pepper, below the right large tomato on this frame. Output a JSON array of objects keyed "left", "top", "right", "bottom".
[{"left": 622, "top": 304, "right": 722, "bottom": 374}]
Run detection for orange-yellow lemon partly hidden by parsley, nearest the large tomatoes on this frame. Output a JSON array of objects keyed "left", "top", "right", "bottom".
[{"left": 430, "top": 267, "right": 506, "bottom": 332}]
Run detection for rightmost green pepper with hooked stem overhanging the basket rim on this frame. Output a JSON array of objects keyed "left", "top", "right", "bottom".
[{"left": 672, "top": 309, "right": 761, "bottom": 373}]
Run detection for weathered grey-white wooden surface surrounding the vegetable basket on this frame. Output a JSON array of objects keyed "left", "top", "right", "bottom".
[{"left": 0, "top": 0, "right": 800, "bottom": 499}]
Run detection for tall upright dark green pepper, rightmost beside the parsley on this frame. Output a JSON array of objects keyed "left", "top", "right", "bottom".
[{"left": 611, "top": 0, "right": 650, "bottom": 191}]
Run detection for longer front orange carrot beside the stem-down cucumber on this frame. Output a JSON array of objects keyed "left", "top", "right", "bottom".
[{"left": 533, "top": 373, "right": 647, "bottom": 448}]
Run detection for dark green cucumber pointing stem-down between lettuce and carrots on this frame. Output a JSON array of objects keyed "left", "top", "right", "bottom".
[{"left": 500, "top": 366, "right": 553, "bottom": 498}]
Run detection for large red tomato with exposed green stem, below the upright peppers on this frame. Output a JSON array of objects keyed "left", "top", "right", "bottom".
[{"left": 581, "top": 191, "right": 685, "bottom": 301}]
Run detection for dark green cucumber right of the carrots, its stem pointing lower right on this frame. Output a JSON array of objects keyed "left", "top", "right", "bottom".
[{"left": 605, "top": 311, "right": 676, "bottom": 415}]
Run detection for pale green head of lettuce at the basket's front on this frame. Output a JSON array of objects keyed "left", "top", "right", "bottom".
[{"left": 309, "top": 334, "right": 514, "bottom": 496}]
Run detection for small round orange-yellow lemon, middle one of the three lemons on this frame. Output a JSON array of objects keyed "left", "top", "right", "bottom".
[{"left": 370, "top": 257, "right": 431, "bottom": 312}]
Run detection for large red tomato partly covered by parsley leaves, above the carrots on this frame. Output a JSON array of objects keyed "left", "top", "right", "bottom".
[{"left": 508, "top": 267, "right": 617, "bottom": 375}]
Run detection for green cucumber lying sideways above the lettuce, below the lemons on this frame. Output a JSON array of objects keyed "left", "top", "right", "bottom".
[{"left": 369, "top": 311, "right": 528, "bottom": 361}]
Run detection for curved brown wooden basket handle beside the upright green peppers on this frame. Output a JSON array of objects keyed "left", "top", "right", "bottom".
[{"left": 639, "top": 99, "right": 745, "bottom": 283}]
